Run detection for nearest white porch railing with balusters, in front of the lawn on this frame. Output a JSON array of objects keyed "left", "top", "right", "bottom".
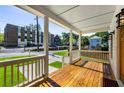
[{"left": 0, "top": 55, "right": 47, "bottom": 87}]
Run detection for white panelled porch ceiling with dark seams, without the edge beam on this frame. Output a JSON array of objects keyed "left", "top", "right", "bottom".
[{"left": 45, "top": 5, "right": 115, "bottom": 33}]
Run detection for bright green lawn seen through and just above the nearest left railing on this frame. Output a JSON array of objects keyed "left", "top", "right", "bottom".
[{"left": 0, "top": 56, "right": 33, "bottom": 86}]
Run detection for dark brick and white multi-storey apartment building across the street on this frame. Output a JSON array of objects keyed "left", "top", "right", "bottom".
[{"left": 4, "top": 24, "right": 43, "bottom": 47}]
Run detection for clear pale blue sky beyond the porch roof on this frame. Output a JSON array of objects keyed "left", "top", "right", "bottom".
[{"left": 0, "top": 5, "right": 91, "bottom": 35}]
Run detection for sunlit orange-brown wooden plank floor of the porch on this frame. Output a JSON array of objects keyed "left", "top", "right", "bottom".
[{"left": 38, "top": 61, "right": 116, "bottom": 87}]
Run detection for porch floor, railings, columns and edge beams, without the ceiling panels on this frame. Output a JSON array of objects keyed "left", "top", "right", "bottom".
[{"left": 0, "top": 5, "right": 121, "bottom": 87}]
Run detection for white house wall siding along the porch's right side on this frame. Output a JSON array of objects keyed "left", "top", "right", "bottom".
[{"left": 109, "top": 5, "right": 124, "bottom": 86}]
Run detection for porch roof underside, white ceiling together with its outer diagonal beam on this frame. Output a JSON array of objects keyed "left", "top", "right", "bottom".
[{"left": 17, "top": 5, "right": 115, "bottom": 33}]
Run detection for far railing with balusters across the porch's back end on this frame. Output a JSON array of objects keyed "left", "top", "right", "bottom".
[{"left": 81, "top": 50, "right": 109, "bottom": 62}]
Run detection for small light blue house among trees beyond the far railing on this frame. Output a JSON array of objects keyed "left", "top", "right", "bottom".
[{"left": 89, "top": 36, "right": 102, "bottom": 50}]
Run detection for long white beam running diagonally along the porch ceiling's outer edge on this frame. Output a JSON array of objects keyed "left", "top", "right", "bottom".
[{"left": 16, "top": 5, "right": 81, "bottom": 33}]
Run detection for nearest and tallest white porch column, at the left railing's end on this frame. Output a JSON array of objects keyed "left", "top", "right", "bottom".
[{"left": 44, "top": 16, "right": 49, "bottom": 78}]
